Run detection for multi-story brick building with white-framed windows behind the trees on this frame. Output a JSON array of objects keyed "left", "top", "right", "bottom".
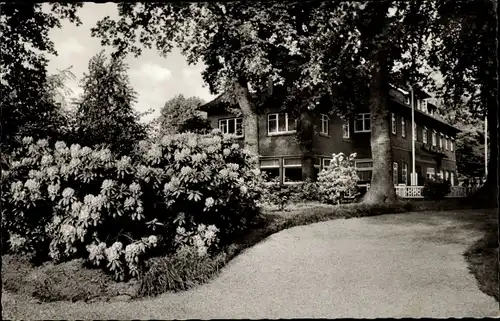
[{"left": 201, "top": 87, "right": 459, "bottom": 185}]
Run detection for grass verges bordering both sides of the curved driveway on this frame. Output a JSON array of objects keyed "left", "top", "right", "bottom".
[{"left": 2, "top": 195, "right": 498, "bottom": 302}]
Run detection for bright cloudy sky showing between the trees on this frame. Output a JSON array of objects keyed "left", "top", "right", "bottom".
[{"left": 48, "top": 3, "right": 215, "bottom": 121}]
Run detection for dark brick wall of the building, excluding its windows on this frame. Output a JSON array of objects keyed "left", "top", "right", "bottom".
[{"left": 201, "top": 90, "right": 458, "bottom": 185}]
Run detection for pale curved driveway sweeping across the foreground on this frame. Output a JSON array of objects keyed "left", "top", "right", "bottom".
[{"left": 2, "top": 211, "right": 498, "bottom": 319}]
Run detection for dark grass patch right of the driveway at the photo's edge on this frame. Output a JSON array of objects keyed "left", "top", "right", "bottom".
[{"left": 464, "top": 215, "right": 500, "bottom": 302}]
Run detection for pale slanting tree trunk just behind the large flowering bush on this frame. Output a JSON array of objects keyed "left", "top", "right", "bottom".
[{"left": 234, "top": 77, "right": 259, "bottom": 155}]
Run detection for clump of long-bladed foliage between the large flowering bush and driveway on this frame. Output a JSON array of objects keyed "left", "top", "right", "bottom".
[{"left": 139, "top": 246, "right": 227, "bottom": 297}]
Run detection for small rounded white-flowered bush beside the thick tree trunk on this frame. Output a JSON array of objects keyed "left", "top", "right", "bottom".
[{"left": 317, "top": 153, "right": 359, "bottom": 204}]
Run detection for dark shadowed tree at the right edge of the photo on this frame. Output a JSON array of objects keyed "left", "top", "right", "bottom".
[{"left": 431, "top": 0, "right": 499, "bottom": 204}]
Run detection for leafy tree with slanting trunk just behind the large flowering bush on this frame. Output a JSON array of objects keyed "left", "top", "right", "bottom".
[{"left": 92, "top": 2, "right": 312, "bottom": 154}]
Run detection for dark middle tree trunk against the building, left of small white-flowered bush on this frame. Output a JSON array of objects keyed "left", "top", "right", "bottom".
[{"left": 297, "top": 108, "right": 315, "bottom": 181}]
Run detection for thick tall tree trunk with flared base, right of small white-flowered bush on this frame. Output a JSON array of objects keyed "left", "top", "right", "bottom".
[{"left": 363, "top": 50, "right": 396, "bottom": 204}]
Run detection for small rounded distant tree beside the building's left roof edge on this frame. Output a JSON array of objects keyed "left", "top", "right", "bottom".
[{"left": 158, "top": 95, "right": 210, "bottom": 135}]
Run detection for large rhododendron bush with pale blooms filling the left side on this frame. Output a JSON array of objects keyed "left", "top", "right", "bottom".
[{"left": 1, "top": 130, "right": 262, "bottom": 279}]
